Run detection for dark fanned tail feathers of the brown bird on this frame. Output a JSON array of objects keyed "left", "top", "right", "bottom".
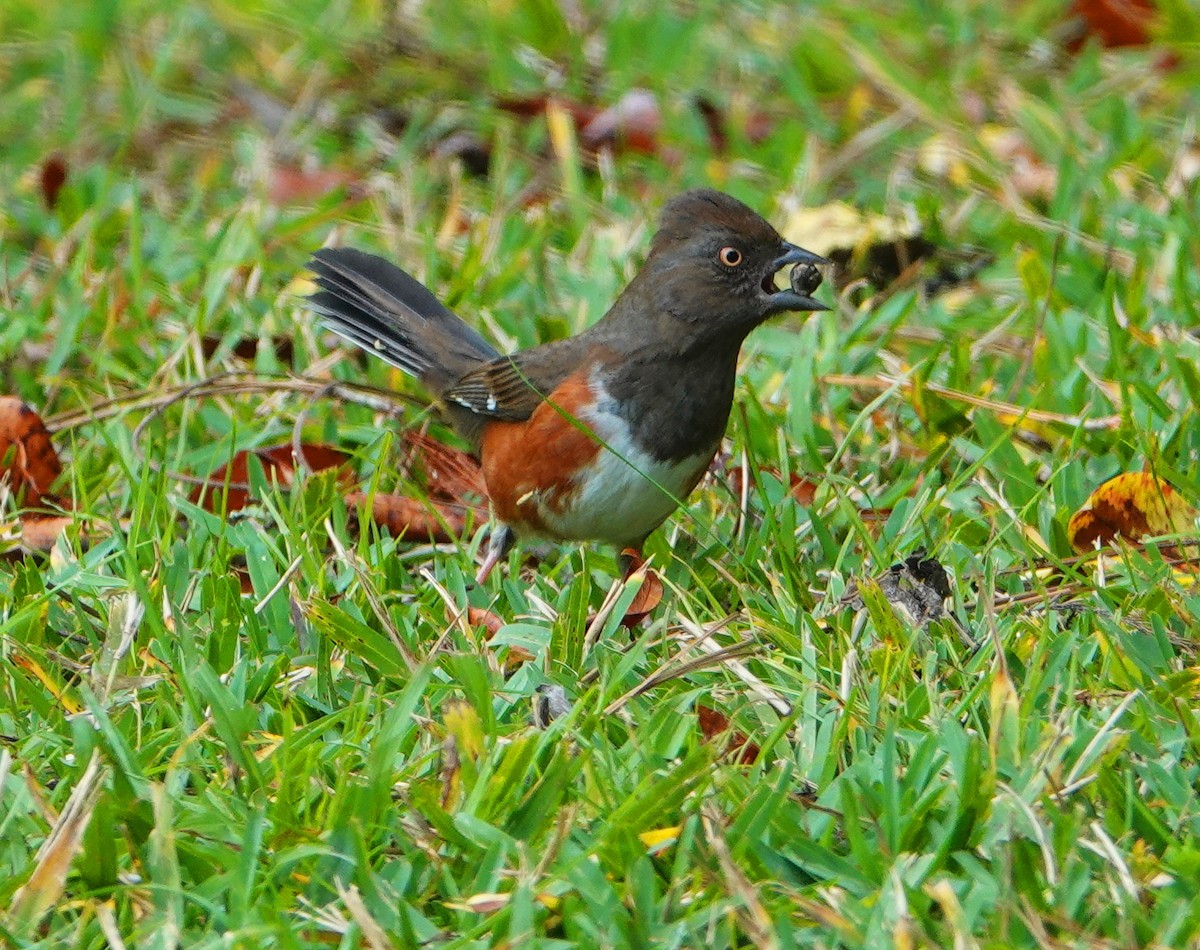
[{"left": 308, "top": 247, "right": 500, "bottom": 395}]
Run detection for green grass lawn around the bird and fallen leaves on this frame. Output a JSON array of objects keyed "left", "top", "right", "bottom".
[{"left": 0, "top": 0, "right": 1200, "bottom": 948}]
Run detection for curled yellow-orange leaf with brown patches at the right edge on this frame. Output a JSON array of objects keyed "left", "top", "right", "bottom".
[{"left": 1067, "top": 471, "right": 1196, "bottom": 552}]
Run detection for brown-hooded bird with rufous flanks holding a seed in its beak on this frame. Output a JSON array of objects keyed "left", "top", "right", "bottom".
[{"left": 307, "top": 188, "right": 829, "bottom": 584}]
